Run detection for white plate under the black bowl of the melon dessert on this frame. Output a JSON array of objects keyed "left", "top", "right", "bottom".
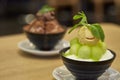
[{"left": 52, "top": 66, "right": 120, "bottom": 80}]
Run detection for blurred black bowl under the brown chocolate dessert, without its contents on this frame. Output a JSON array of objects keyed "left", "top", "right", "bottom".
[{"left": 25, "top": 31, "right": 65, "bottom": 50}]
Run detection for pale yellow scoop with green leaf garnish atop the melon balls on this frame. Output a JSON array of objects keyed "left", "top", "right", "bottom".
[{"left": 69, "top": 12, "right": 105, "bottom": 44}]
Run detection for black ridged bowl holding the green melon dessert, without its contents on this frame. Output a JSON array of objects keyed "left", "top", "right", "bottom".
[{"left": 60, "top": 47, "right": 116, "bottom": 80}]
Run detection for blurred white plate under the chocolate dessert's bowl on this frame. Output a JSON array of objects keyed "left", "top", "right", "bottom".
[{"left": 18, "top": 40, "right": 69, "bottom": 56}]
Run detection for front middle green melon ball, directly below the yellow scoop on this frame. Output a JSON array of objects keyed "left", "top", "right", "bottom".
[{"left": 78, "top": 45, "right": 91, "bottom": 59}]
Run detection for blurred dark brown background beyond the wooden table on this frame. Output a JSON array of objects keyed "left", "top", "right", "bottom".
[{"left": 0, "top": 0, "right": 120, "bottom": 36}]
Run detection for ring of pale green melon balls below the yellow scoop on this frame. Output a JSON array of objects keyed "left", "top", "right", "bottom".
[{"left": 66, "top": 38, "right": 106, "bottom": 61}]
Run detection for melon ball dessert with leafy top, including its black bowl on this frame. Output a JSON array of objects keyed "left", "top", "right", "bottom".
[{"left": 60, "top": 12, "right": 116, "bottom": 80}]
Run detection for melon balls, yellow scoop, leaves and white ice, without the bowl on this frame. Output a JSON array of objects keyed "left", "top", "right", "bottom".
[{"left": 64, "top": 12, "right": 113, "bottom": 61}]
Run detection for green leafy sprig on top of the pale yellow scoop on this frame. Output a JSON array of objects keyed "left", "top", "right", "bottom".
[{"left": 69, "top": 12, "right": 105, "bottom": 41}]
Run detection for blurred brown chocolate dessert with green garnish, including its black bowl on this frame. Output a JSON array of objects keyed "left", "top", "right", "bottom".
[{"left": 23, "top": 5, "right": 66, "bottom": 50}]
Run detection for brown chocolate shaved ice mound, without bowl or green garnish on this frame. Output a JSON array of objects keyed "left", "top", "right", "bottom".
[{"left": 24, "top": 8, "right": 64, "bottom": 34}]
